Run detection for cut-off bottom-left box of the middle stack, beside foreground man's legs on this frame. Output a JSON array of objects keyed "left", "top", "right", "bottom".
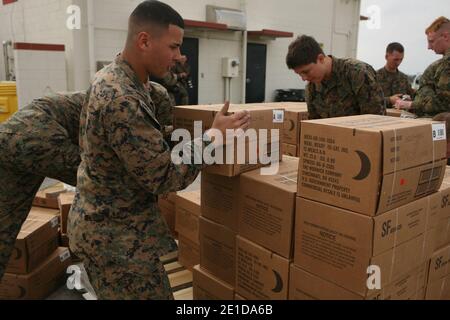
[{"left": 192, "top": 265, "right": 234, "bottom": 300}]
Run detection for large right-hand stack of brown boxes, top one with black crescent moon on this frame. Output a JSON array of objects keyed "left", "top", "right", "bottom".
[{"left": 289, "top": 115, "right": 446, "bottom": 299}]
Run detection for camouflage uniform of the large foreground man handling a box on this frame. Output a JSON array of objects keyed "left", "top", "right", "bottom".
[{"left": 68, "top": 55, "right": 207, "bottom": 299}]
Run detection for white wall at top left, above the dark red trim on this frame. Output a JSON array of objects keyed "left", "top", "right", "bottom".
[{"left": 0, "top": 0, "right": 89, "bottom": 90}]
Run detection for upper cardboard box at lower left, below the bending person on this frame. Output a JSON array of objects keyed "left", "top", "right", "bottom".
[{"left": 6, "top": 208, "right": 59, "bottom": 274}]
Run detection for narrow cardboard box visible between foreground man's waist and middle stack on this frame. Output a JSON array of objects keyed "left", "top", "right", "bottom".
[{"left": 175, "top": 190, "right": 201, "bottom": 245}]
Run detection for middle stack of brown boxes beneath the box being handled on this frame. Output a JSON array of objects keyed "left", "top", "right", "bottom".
[{"left": 194, "top": 156, "right": 298, "bottom": 300}]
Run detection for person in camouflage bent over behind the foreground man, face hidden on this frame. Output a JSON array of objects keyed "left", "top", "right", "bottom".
[{"left": 0, "top": 82, "right": 173, "bottom": 279}]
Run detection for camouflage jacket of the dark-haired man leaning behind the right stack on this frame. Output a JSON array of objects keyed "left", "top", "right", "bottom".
[{"left": 306, "top": 57, "right": 385, "bottom": 119}]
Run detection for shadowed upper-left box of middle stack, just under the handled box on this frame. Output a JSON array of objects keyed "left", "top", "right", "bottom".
[{"left": 201, "top": 172, "right": 239, "bottom": 233}]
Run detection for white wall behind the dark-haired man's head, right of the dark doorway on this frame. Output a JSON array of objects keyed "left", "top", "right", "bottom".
[{"left": 245, "top": 0, "right": 359, "bottom": 100}]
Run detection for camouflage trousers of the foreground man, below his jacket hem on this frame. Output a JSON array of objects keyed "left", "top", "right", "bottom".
[{"left": 75, "top": 252, "right": 173, "bottom": 300}]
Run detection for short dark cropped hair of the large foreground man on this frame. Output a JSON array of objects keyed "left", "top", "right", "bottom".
[{"left": 129, "top": 0, "right": 184, "bottom": 34}]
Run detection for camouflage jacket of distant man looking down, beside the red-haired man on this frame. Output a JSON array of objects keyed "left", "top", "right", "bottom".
[{"left": 377, "top": 67, "right": 414, "bottom": 108}]
